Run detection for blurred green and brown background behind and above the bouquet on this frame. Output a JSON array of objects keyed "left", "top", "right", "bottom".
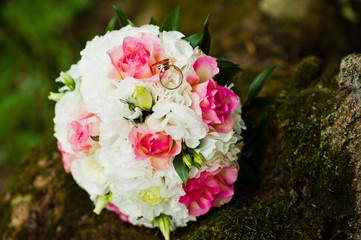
[{"left": 0, "top": 0, "right": 361, "bottom": 172}]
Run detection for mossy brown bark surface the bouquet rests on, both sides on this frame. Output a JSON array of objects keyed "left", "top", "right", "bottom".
[{"left": 0, "top": 56, "right": 361, "bottom": 239}]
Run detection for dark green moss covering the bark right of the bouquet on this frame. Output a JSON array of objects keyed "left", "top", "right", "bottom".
[{"left": 176, "top": 66, "right": 356, "bottom": 240}]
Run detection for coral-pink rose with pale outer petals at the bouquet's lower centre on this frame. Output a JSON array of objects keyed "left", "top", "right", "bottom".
[{"left": 128, "top": 127, "right": 182, "bottom": 170}]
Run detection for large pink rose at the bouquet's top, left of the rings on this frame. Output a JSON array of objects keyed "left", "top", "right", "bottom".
[{"left": 107, "top": 33, "right": 167, "bottom": 82}]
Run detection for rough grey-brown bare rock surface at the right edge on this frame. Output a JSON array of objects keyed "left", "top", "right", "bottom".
[{"left": 323, "top": 54, "right": 361, "bottom": 239}]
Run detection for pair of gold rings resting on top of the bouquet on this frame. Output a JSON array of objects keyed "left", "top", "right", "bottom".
[{"left": 152, "top": 59, "right": 183, "bottom": 90}]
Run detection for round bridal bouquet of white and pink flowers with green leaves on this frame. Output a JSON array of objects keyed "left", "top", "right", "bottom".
[{"left": 49, "top": 8, "right": 253, "bottom": 238}]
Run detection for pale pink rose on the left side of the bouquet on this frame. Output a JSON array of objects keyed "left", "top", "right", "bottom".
[{"left": 68, "top": 113, "right": 100, "bottom": 152}]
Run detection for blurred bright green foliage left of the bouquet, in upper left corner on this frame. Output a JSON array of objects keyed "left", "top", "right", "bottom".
[{"left": 0, "top": 0, "right": 93, "bottom": 165}]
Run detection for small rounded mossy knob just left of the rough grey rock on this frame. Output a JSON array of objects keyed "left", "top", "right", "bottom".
[{"left": 292, "top": 56, "right": 321, "bottom": 90}]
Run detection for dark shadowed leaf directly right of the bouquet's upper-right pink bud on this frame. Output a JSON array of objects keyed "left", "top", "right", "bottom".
[{"left": 214, "top": 60, "right": 242, "bottom": 86}]
